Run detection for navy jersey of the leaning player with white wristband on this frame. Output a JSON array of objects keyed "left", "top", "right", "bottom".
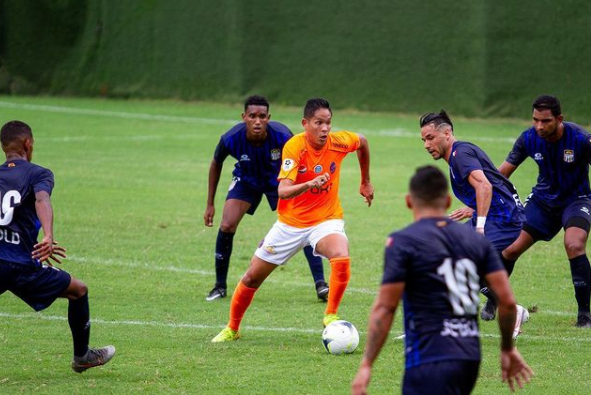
[{"left": 449, "top": 141, "right": 525, "bottom": 223}]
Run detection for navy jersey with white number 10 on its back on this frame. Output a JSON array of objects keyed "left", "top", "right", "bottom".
[{"left": 382, "top": 218, "right": 504, "bottom": 368}]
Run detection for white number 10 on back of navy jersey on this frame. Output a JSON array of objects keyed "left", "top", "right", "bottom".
[{"left": 437, "top": 258, "right": 480, "bottom": 315}]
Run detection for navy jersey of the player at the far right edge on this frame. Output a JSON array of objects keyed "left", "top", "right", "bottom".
[{"left": 506, "top": 122, "right": 591, "bottom": 208}]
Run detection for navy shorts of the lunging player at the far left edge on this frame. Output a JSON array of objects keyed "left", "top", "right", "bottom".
[{"left": 0, "top": 260, "right": 72, "bottom": 311}]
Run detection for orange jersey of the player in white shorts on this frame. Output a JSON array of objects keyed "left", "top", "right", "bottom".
[{"left": 277, "top": 130, "right": 361, "bottom": 228}]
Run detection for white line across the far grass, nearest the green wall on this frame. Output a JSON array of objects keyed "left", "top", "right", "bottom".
[{"left": 0, "top": 101, "right": 521, "bottom": 143}]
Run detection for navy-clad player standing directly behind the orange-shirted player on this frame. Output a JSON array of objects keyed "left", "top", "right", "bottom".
[{"left": 203, "top": 95, "right": 328, "bottom": 302}]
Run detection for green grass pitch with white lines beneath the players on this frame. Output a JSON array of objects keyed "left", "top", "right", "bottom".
[{"left": 0, "top": 96, "right": 591, "bottom": 395}]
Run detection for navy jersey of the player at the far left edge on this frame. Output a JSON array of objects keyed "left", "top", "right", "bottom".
[{"left": 0, "top": 159, "right": 53, "bottom": 266}]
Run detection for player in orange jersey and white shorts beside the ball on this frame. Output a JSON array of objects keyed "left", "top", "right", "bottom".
[{"left": 212, "top": 99, "right": 373, "bottom": 343}]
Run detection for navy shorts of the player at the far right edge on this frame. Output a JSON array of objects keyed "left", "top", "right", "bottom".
[{"left": 525, "top": 198, "right": 591, "bottom": 241}]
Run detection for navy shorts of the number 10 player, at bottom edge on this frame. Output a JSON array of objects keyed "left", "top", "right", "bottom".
[{"left": 402, "top": 360, "right": 480, "bottom": 395}]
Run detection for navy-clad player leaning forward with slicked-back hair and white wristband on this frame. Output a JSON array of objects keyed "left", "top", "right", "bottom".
[{"left": 419, "top": 110, "right": 529, "bottom": 324}]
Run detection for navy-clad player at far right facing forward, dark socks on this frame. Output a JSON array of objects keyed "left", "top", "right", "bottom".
[{"left": 499, "top": 96, "right": 591, "bottom": 328}]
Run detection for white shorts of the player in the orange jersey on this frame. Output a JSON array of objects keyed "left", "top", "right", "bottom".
[{"left": 254, "top": 219, "right": 348, "bottom": 265}]
